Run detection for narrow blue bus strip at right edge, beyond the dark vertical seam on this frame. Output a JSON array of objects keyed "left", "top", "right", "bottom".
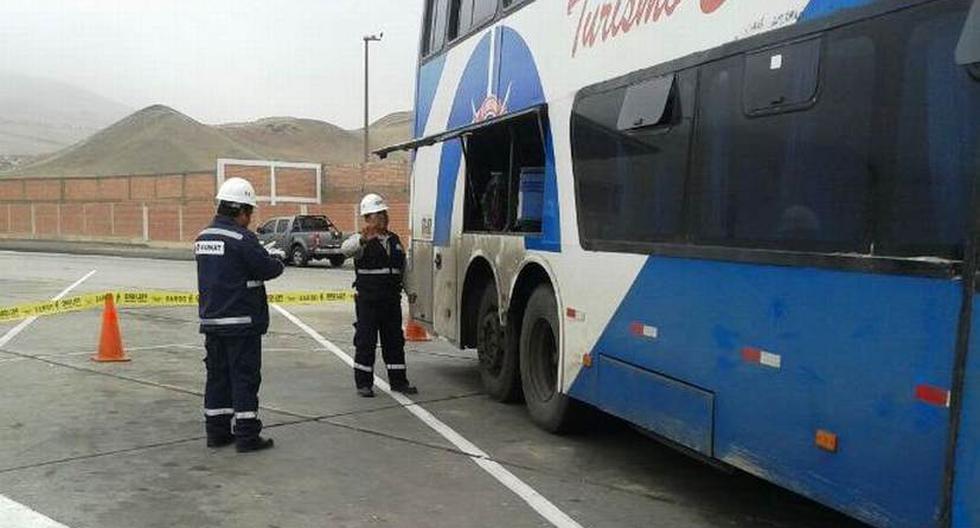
[{"left": 953, "top": 301, "right": 980, "bottom": 528}]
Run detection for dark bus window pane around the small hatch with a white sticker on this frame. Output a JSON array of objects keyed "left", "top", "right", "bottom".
[{"left": 695, "top": 33, "right": 875, "bottom": 253}]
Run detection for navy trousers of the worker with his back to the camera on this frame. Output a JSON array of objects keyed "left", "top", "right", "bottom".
[{"left": 204, "top": 334, "right": 262, "bottom": 438}]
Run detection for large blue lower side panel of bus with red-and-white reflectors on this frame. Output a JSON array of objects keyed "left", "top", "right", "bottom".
[{"left": 571, "top": 257, "right": 960, "bottom": 528}]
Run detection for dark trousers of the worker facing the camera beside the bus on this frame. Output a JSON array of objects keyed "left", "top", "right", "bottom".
[{"left": 354, "top": 297, "right": 408, "bottom": 389}]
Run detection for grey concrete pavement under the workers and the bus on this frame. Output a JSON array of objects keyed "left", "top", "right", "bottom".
[{"left": 0, "top": 252, "right": 860, "bottom": 528}]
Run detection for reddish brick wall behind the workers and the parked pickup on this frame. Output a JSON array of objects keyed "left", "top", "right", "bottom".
[{"left": 0, "top": 162, "right": 409, "bottom": 244}]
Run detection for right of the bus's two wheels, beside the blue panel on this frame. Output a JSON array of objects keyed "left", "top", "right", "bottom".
[{"left": 520, "top": 284, "right": 577, "bottom": 433}]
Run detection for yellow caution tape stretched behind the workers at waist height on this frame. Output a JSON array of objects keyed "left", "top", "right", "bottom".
[{"left": 0, "top": 290, "right": 354, "bottom": 322}]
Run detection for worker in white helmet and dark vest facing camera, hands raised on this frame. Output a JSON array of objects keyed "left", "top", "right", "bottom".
[{"left": 341, "top": 194, "right": 418, "bottom": 398}]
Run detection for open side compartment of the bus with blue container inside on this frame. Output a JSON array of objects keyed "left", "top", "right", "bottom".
[{"left": 463, "top": 114, "right": 546, "bottom": 233}]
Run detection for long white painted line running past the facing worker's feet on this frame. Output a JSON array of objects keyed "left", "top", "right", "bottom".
[{"left": 271, "top": 304, "right": 582, "bottom": 528}]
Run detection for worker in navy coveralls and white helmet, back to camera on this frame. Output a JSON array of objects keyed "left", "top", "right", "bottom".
[{"left": 194, "top": 178, "right": 283, "bottom": 453}]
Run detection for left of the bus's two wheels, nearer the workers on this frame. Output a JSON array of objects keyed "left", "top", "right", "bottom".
[{"left": 476, "top": 283, "right": 521, "bottom": 402}]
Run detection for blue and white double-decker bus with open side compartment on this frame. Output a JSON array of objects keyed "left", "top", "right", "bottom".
[{"left": 379, "top": 0, "right": 980, "bottom": 528}]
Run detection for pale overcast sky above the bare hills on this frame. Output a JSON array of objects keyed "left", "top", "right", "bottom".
[{"left": 0, "top": 0, "right": 422, "bottom": 128}]
